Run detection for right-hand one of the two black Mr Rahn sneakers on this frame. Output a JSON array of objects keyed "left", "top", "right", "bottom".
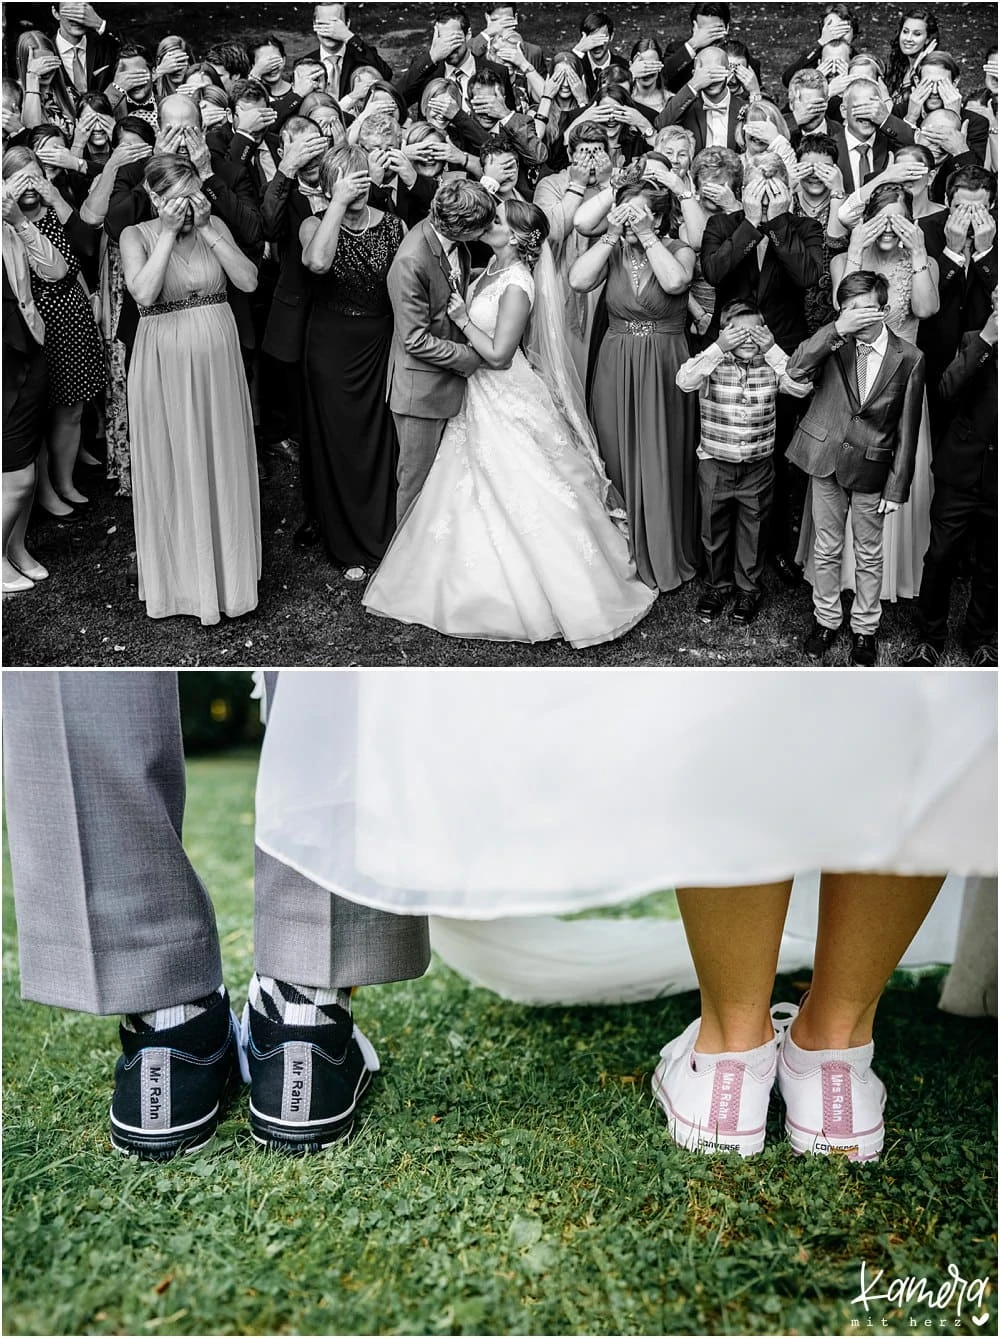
[{"left": 242, "top": 1004, "right": 380, "bottom": 1152}]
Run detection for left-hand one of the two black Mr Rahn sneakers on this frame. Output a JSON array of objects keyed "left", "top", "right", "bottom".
[{"left": 111, "top": 994, "right": 249, "bottom": 1161}]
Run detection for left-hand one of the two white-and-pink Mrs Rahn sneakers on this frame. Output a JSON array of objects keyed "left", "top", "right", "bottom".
[{"left": 652, "top": 1018, "right": 778, "bottom": 1157}]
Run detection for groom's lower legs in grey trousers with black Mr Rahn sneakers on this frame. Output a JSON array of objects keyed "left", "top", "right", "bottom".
[{"left": 4, "top": 670, "right": 430, "bottom": 1160}]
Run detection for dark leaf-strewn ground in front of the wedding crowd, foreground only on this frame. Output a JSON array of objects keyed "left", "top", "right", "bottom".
[{"left": 4, "top": 459, "right": 967, "bottom": 668}]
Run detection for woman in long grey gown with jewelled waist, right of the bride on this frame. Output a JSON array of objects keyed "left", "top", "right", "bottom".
[{"left": 570, "top": 182, "right": 697, "bottom": 590}]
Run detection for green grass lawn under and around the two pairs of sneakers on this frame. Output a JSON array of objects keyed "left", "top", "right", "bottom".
[{"left": 3, "top": 752, "right": 996, "bottom": 1334}]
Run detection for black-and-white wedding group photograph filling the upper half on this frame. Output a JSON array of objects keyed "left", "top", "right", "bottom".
[{"left": 3, "top": 4, "right": 997, "bottom": 668}]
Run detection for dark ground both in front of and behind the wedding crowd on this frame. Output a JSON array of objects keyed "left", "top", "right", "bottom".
[{"left": 3, "top": 4, "right": 996, "bottom": 666}]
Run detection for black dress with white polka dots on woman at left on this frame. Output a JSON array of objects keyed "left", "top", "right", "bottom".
[{"left": 31, "top": 209, "right": 107, "bottom": 405}]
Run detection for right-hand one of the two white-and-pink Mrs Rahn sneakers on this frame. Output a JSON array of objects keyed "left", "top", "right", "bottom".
[{"left": 778, "top": 1036, "right": 885, "bottom": 1161}]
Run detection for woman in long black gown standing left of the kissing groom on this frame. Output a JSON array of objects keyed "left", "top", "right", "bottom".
[{"left": 299, "top": 147, "right": 403, "bottom": 581}]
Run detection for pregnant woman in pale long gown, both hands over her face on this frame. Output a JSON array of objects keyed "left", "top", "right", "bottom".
[{"left": 120, "top": 154, "right": 261, "bottom": 626}]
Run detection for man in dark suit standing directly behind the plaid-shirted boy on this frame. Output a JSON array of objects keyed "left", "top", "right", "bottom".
[{"left": 701, "top": 154, "right": 823, "bottom": 586}]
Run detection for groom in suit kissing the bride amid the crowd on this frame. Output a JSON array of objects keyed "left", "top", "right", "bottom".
[{"left": 387, "top": 179, "right": 497, "bottom": 523}]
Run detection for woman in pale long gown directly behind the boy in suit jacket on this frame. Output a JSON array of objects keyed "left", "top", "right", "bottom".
[{"left": 798, "top": 185, "right": 940, "bottom": 601}]
